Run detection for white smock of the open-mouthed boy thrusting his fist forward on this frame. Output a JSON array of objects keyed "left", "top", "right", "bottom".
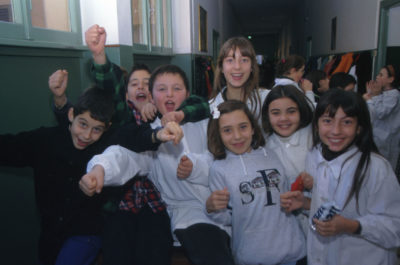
[{"left": 88, "top": 119, "right": 223, "bottom": 231}]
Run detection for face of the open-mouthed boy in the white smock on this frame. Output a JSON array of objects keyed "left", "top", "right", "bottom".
[{"left": 153, "top": 73, "right": 189, "bottom": 115}]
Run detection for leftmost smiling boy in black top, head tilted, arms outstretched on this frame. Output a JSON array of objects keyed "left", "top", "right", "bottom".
[{"left": 0, "top": 87, "right": 181, "bottom": 265}]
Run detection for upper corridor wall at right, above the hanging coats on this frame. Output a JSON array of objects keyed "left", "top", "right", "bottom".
[{"left": 305, "top": 0, "right": 380, "bottom": 55}]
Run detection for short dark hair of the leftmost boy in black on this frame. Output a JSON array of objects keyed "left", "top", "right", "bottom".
[{"left": 73, "top": 86, "right": 114, "bottom": 127}]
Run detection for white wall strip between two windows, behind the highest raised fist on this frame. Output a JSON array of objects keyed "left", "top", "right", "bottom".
[{"left": 80, "top": 0, "right": 132, "bottom": 45}]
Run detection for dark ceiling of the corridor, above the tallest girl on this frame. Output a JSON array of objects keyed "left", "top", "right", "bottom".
[{"left": 228, "top": 0, "right": 304, "bottom": 35}]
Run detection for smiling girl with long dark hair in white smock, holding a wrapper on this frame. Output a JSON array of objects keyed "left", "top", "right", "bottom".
[{"left": 281, "top": 89, "right": 400, "bottom": 265}]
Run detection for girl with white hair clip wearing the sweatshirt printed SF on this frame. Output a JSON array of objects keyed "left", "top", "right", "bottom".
[{"left": 207, "top": 100, "right": 305, "bottom": 264}]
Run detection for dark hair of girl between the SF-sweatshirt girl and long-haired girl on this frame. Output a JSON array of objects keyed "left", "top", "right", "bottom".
[{"left": 261, "top": 85, "right": 313, "bottom": 134}]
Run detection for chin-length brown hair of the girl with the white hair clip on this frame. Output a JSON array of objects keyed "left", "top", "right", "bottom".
[{"left": 207, "top": 100, "right": 265, "bottom": 159}]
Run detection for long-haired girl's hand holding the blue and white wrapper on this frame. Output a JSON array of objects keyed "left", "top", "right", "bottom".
[{"left": 313, "top": 214, "right": 360, "bottom": 236}]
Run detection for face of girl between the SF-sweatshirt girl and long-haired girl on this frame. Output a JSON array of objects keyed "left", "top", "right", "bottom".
[{"left": 268, "top": 97, "right": 300, "bottom": 137}]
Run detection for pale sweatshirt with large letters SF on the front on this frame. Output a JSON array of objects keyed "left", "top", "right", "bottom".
[{"left": 210, "top": 148, "right": 306, "bottom": 265}]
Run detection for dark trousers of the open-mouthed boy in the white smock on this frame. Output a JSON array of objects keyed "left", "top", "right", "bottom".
[{"left": 174, "top": 223, "right": 234, "bottom": 265}]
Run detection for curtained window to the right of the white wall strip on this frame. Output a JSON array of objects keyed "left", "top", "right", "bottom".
[{"left": 131, "top": 0, "right": 172, "bottom": 53}]
